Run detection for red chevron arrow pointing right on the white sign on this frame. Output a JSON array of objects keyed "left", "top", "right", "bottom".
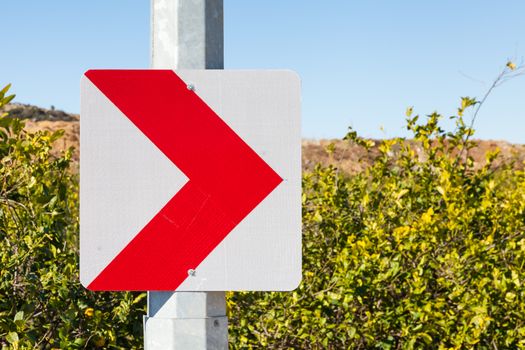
[{"left": 86, "top": 70, "right": 282, "bottom": 290}]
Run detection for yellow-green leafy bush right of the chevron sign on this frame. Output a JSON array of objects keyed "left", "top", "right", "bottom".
[{"left": 229, "top": 98, "right": 525, "bottom": 349}]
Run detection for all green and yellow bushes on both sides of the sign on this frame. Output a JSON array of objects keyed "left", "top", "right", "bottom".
[{"left": 0, "top": 64, "right": 525, "bottom": 349}]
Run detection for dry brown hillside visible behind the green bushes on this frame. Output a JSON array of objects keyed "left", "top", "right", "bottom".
[{"left": 5, "top": 104, "right": 525, "bottom": 173}]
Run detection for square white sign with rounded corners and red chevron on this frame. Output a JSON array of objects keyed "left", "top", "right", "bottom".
[{"left": 80, "top": 70, "right": 301, "bottom": 291}]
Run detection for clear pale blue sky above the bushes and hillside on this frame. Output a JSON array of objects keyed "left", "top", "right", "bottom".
[{"left": 0, "top": 0, "right": 525, "bottom": 143}]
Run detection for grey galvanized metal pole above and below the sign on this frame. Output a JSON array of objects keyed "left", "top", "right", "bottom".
[{"left": 144, "top": 0, "right": 228, "bottom": 350}]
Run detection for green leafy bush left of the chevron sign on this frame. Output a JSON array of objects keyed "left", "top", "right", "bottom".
[{"left": 0, "top": 86, "right": 145, "bottom": 349}]
